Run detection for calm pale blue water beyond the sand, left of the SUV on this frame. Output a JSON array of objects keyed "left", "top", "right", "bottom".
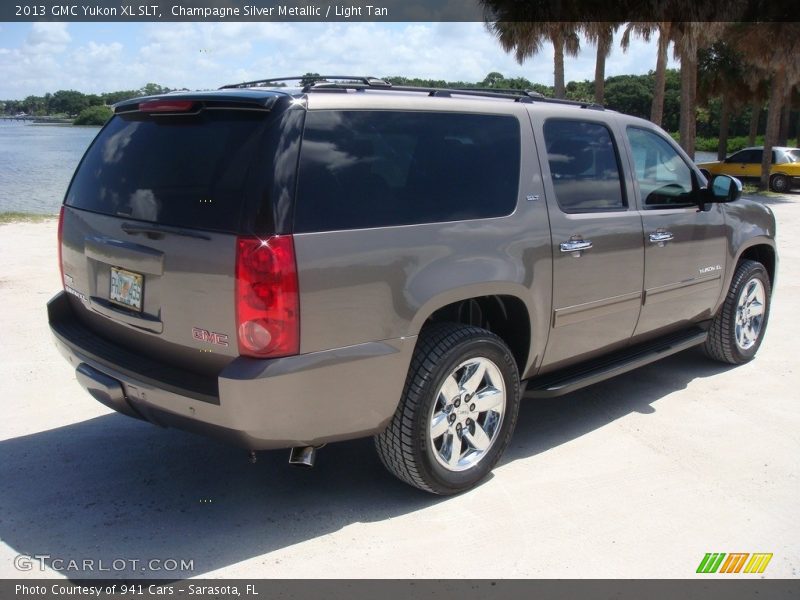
[{"left": 0, "top": 120, "right": 100, "bottom": 214}]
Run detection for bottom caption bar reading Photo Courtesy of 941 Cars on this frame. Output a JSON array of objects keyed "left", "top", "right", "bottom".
[{"left": 0, "top": 575, "right": 800, "bottom": 600}]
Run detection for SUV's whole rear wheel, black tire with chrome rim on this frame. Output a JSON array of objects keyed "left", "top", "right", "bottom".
[{"left": 375, "top": 323, "right": 520, "bottom": 495}]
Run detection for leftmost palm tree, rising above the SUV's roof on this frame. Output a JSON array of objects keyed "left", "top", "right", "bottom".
[{"left": 487, "top": 21, "right": 580, "bottom": 98}]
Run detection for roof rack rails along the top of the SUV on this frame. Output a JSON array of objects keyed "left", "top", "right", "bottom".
[{"left": 220, "top": 75, "right": 605, "bottom": 110}]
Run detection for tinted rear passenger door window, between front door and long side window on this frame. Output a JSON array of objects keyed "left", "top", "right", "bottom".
[{"left": 544, "top": 119, "right": 626, "bottom": 212}]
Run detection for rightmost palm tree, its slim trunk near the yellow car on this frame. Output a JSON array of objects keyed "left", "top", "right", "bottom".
[{"left": 730, "top": 22, "right": 800, "bottom": 190}]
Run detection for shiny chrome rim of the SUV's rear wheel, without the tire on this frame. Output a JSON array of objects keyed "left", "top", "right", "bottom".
[{"left": 428, "top": 357, "right": 506, "bottom": 471}]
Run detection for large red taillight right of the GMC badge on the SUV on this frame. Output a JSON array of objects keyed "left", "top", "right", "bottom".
[{"left": 236, "top": 235, "right": 300, "bottom": 358}]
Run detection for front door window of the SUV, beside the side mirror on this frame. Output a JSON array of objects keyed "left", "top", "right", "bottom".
[{"left": 626, "top": 127, "right": 694, "bottom": 208}]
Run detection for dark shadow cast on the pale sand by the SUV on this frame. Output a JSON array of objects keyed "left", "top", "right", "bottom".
[{"left": 0, "top": 351, "right": 726, "bottom": 579}]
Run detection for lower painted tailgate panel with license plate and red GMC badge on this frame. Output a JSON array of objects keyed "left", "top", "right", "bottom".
[{"left": 62, "top": 207, "right": 238, "bottom": 373}]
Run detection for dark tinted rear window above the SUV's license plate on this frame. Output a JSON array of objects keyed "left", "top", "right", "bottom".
[{"left": 65, "top": 110, "right": 284, "bottom": 233}]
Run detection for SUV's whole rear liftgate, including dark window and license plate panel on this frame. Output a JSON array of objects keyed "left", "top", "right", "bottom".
[{"left": 56, "top": 96, "right": 302, "bottom": 375}]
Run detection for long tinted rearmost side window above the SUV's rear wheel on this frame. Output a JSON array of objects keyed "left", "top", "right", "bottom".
[{"left": 295, "top": 111, "right": 520, "bottom": 232}]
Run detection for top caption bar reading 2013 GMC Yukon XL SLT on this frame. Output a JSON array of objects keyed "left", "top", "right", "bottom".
[{"left": 0, "top": 0, "right": 800, "bottom": 22}]
